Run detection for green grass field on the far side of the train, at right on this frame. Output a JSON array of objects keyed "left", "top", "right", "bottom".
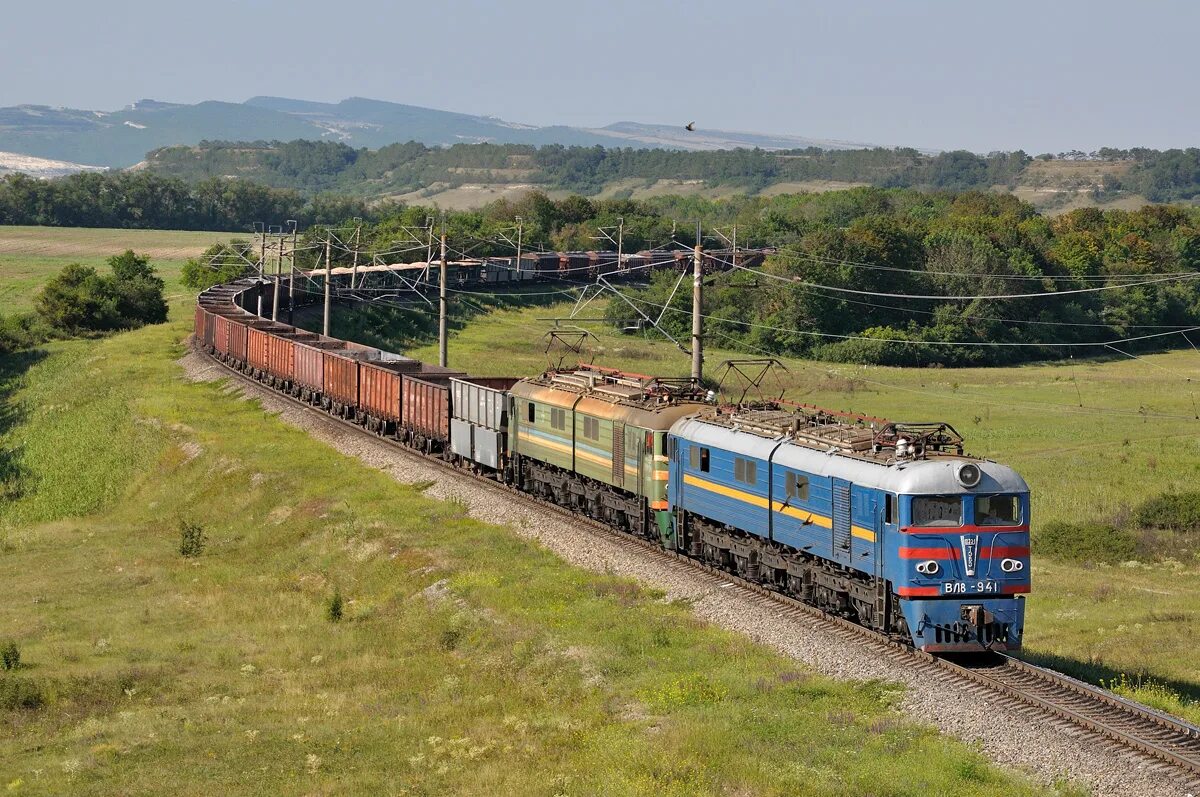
[{"left": 396, "top": 298, "right": 1200, "bottom": 720}]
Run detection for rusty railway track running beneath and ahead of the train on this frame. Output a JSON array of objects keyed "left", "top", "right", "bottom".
[{"left": 196, "top": 347, "right": 1200, "bottom": 795}]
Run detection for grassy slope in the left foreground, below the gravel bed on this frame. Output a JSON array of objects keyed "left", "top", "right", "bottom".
[{"left": 0, "top": 246, "right": 1070, "bottom": 796}]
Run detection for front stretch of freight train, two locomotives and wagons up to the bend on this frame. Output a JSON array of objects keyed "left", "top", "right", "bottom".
[{"left": 196, "top": 280, "right": 1030, "bottom": 653}]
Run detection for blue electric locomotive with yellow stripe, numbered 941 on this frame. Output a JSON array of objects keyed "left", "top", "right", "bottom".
[{"left": 668, "top": 405, "right": 1030, "bottom": 653}]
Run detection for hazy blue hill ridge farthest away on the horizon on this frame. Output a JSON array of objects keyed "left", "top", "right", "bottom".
[{"left": 0, "top": 97, "right": 862, "bottom": 168}]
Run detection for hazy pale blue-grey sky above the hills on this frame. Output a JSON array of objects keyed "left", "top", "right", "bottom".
[{"left": 0, "top": 0, "right": 1200, "bottom": 154}]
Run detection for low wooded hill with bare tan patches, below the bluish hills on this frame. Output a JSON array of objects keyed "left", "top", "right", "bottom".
[{"left": 142, "top": 140, "right": 1200, "bottom": 211}]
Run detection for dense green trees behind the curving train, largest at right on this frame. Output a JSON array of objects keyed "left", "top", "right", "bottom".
[{"left": 243, "top": 188, "right": 1200, "bottom": 366}]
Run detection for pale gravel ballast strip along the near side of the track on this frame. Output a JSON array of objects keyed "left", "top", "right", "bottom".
[{"left": 180, "top": 352, "right": 1193, "bottom": 797}]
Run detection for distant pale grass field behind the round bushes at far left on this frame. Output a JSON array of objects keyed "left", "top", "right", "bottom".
[{"left": 0, "top": 226, "right": 232, "bottom": 316}]
